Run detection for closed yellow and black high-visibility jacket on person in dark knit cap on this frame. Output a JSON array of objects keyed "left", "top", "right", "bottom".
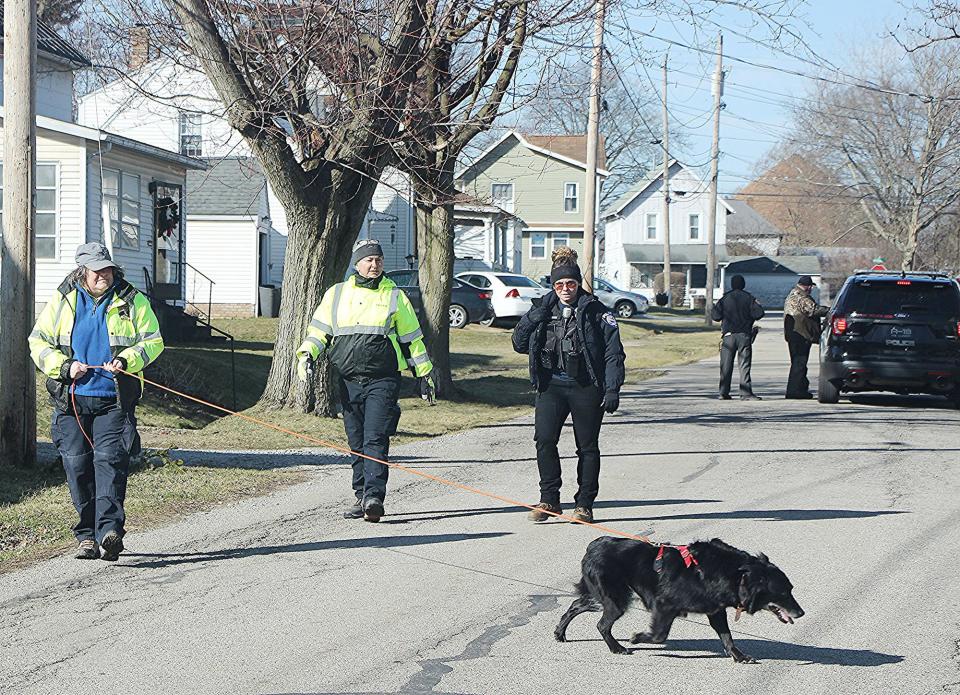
[{"left": 297, "top": 276, "right": 433, "bottom": 379}]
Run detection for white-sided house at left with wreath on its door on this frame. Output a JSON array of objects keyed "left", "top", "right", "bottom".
[{"left": 0, "top": 12, "right": 204, "bottom": 310}]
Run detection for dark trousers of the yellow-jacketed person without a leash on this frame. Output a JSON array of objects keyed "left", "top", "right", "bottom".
[{"left": 340, "top": 373, "right": 400, "bottom": 502}]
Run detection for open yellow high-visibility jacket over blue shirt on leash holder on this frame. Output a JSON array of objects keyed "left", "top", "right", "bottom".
[{"left": 29, "top": 279, "right": 164, "bottom": 412}]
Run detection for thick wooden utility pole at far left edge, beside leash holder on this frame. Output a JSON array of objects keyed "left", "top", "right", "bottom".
[{"left": 0, "top": 0, "right": 37, "bottom": 466}]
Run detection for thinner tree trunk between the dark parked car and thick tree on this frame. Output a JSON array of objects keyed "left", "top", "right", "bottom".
[{"left": 416, "top": 167, "right": 456, "bottom": 398}]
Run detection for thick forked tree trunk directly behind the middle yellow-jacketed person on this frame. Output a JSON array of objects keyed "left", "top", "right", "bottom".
[{"left": 260, "top": 173, "right": 377, "bottom": 417}]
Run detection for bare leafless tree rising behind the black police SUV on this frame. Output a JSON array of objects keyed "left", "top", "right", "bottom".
[{"left": 795, "top": 45, "right": 960, "bottom": 269}]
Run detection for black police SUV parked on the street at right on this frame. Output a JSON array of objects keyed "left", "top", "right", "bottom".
[{"left": 817, "top": 271, "right": 960, "bottom": 406}]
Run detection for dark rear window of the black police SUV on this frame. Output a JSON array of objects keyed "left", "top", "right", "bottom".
[{"left": 843, "top": 280, "right": 960, "bottom": 319}]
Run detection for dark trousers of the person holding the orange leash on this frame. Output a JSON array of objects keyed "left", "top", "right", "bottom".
[{"left": 50, "top": 396, "right": 140, "bottom": 542}]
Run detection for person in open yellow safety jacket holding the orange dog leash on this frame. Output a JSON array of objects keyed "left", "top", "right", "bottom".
[{"left": 29, "top": 242, "right": 163, "bottom": 561}]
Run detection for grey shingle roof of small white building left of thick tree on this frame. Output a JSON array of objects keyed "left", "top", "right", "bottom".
[{"left": 187, "top": 157, "right": 267, "bottom": 217}]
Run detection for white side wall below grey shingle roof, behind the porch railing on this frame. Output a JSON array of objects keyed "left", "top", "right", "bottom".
[{"left": 186, "top": 217, "right": 258, "bottom": 311}]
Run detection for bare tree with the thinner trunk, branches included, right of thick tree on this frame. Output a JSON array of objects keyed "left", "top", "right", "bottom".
[{"left": 396, "top": 0, "right": 593, "bottom": 396}]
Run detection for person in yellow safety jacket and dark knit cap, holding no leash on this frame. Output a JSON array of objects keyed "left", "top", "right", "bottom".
[{"left": 297, "top": 239, "right": 435, "bottom": 522}]
